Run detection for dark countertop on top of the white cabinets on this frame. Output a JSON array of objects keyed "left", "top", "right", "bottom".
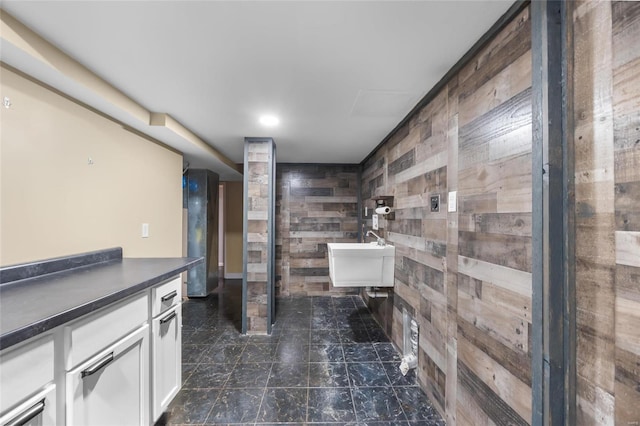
[{"left": 0, "top": 251, "right": 203, "bottom": 349}]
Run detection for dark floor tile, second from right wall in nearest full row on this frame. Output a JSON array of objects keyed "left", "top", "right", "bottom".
[{"left": 351, "top": 387, "right": 406, "bottom": 422}]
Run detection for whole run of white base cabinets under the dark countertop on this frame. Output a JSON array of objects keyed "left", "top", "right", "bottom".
[{"left": 0, "top": 272, "right": 182, "bottom": 426}]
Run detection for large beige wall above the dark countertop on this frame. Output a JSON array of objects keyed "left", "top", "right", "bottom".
[{"left": 0, "top": 67, "right": 182, "bottom": 265}]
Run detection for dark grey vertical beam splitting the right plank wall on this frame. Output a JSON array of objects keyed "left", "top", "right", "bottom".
[{"left": 531, "top": 0, "right": 575, "bottom": 425}]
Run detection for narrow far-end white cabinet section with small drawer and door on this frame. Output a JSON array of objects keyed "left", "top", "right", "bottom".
[{"left": 151, "top": 278, "right": 182, "bottom": 423}]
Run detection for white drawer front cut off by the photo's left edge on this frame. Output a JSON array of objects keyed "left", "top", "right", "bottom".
[{"left": 0, "top": 334, "right": 54, "bottom": 413}]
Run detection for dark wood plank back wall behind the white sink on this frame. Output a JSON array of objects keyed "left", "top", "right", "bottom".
[{"left": 276, "top": 164, "right": 360, "bottom": 296}]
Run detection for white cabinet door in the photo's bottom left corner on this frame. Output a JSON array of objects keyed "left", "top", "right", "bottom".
[{"left": 0, "top": 384, "right": 56, "bottom": 426}]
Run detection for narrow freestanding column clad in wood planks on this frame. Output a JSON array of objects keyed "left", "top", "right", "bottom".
[{"left": 245, "top": 141, "right": 275, "bottom": 334}]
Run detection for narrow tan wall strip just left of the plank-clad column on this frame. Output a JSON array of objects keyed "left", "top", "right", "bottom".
[{"left": 225, "top": 182, "right": 243, "bottom": 274}]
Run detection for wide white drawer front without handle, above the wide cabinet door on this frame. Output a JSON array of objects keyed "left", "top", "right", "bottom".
[{"left": 65, "top": 292, "right": 149, "bottom": 371}]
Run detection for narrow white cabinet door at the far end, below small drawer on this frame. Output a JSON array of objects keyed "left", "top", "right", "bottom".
[{"left": 151, "top": 305, "right": 182, "bottom": 421}]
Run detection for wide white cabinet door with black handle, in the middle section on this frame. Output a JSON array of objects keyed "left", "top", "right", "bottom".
[{"left": 66, "top": 324, "right": 149, "bottom": 426}]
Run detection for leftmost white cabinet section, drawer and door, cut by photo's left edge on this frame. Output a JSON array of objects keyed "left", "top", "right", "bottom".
[{"left": 0, "top": 334, "right": 57, "bottom": 425}]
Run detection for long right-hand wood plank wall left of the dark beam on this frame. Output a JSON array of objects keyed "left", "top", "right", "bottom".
[{"left": 362, "top": 9, "right": 532, "bottom": 425}]
